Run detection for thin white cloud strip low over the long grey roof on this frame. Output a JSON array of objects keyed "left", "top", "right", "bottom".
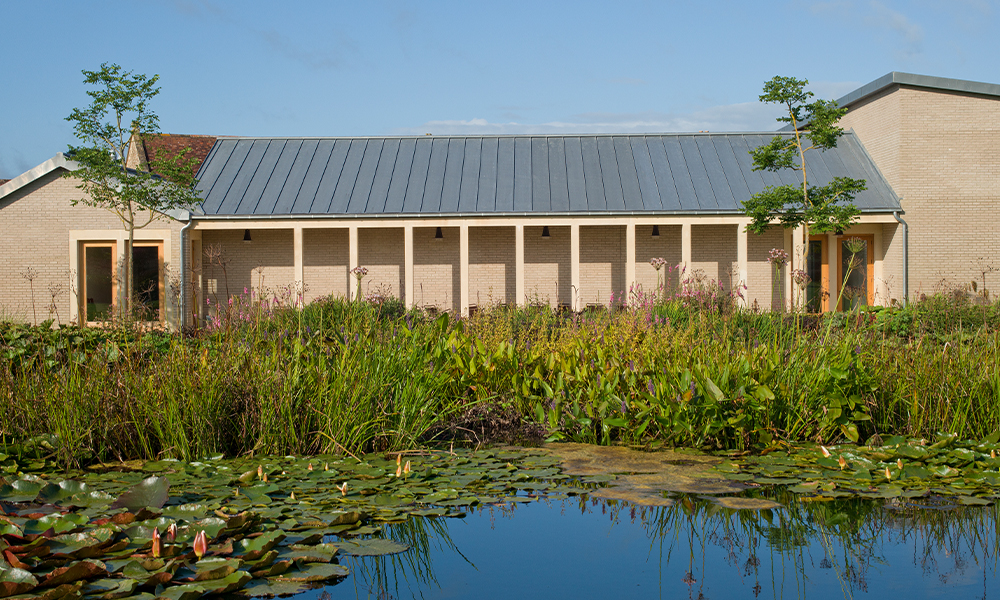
[{"left": 392, "top": 102, "right": 781, "bottom": 135}]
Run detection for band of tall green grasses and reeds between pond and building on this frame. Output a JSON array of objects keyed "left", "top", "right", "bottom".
[{"left": 0, "top": 284, "right": 1000, "bottom": 464}]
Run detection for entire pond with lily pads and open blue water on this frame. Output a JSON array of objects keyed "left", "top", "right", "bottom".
[{"left": 0, "top": 438, "right": 1000, "bottom": 600}]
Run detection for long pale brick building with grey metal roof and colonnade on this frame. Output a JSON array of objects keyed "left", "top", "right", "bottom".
[{"left": 0, "top": 73, "right": 1000, "bottom": 324}]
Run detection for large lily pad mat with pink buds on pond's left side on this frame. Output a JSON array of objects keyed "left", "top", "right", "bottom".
[{"left": 0, "top": 449, "right": 601, "bottom": 600}]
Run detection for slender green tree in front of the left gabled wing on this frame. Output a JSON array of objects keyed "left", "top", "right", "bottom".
[{"left": 66, "top": 63, "right": 199, "bottom": 315}]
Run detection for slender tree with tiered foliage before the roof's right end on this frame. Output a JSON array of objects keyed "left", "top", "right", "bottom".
[{"left": 743, "top": 77, "right": 865, "bottom": 270}]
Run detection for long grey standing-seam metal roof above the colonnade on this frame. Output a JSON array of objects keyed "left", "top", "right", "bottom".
[{"left": 197, "top": 132, "right": 899, "bottom": 218}]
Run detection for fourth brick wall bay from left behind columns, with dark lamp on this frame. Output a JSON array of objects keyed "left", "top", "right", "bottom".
[{"left": 412, "top": 227, "right": 461, "bottom": 311}]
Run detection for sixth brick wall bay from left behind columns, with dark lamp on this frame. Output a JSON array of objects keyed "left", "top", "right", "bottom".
[{"left": 519, "top": 226, "right": 572, "bottom": 308}]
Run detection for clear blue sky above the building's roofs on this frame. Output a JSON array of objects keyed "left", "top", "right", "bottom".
[{"left": 0, "top": 0, "right": 1000, "bottom": 178}]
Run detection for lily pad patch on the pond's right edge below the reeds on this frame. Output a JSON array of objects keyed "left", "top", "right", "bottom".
[{"left": 714, "top": 434, "right": 1000, "bottom": 505}]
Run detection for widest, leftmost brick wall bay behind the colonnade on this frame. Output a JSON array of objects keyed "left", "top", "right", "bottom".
[{"left": 201, "top": 229, "right": 294, "bottom": 314}]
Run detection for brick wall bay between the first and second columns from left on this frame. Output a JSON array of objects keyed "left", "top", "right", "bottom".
[{"left": 302, "top": 227, "right": 354, "bottom": 303}]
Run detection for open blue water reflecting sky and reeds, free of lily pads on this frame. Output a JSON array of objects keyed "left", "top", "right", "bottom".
[{"left": 299, "top": 499, "right": 1000, "bottom": 599}]
